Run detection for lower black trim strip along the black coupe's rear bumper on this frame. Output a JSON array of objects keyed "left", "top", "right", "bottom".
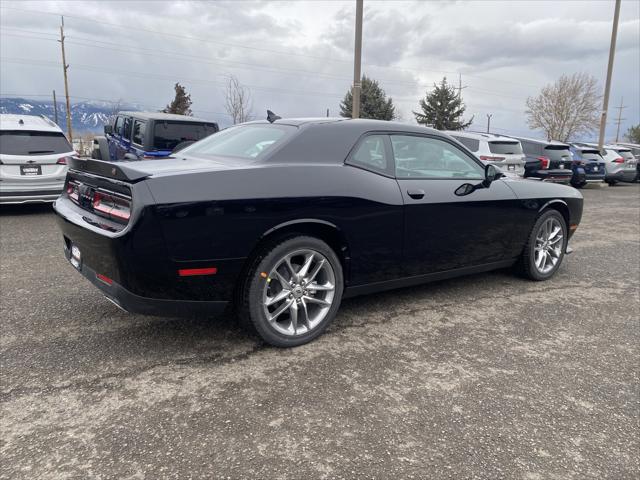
[{"left": 64, "top": 245, "right": 228, "bottom": 317}]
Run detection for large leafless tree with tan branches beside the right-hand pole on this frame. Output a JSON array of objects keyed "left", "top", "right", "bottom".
[{"left": 525, "top": 73, "right": 600, "bottom": 142}]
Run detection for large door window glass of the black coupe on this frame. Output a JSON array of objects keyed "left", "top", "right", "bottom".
[{"left": 391, "top": 135, "right": 484, "bottom": 180}]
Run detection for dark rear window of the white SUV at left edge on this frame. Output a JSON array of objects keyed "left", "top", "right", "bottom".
[{"left": 0, "top": 130, "right": 73, "bottom": 155}]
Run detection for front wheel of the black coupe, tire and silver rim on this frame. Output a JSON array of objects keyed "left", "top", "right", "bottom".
[{"left": 516, "top": 209, "right": 568, "bottom": 281}]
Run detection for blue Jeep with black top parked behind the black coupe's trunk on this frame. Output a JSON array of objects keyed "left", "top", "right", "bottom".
[{"left": 92, "top": 112, "right": 219, "bottom": 161}]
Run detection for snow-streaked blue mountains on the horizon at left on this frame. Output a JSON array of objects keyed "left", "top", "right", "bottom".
[{"left": 0, "top": 97, "right": 140, "bottom": 134}]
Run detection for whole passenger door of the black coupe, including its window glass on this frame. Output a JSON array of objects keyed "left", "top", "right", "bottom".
[{"left": 389, "top": 134, "right": 519, "bottom": 275}]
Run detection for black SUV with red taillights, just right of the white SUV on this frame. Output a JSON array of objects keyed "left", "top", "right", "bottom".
[{"left": 513, "top": 137, "right": 573, "bottom": 184}]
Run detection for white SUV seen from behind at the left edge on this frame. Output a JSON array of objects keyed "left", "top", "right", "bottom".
[{"left": 0, "top": 114, "right": 76, "bottom": 203}]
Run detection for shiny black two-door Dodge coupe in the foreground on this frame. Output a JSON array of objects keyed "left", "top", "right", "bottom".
[{"left": 55, "top": 118, "right": 582, "bottom": 346}]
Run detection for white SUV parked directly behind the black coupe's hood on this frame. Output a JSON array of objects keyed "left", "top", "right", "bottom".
[{"left": 444, "top": 130, "right": 527, "bottom": 177}]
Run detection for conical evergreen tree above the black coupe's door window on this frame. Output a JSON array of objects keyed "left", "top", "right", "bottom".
[{"left": 413, "top": 77, "right": 473, "bottom": 130}]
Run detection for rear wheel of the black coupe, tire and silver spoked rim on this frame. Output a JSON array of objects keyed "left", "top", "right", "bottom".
[{"left": 238, "top": 236, "right": 344, "bottom": 347}]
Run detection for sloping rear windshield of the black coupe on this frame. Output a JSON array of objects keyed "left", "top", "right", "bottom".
[{"left": 180, "top": 125, "right": 296, "bottom": 159}]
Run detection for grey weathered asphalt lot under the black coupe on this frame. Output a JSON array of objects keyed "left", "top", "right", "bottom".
[{"left": 0, "top": 185, "right": 640, "bottom": 480}]
